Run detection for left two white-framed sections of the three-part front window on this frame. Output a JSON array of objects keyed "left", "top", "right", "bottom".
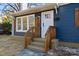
[{"left": 16, "top": 16, "right": 28, "bottom": 32}]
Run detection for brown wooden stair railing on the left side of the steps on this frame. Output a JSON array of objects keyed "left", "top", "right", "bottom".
[{"left": 24, "top": 27, "right": 35, "bottom": 48}]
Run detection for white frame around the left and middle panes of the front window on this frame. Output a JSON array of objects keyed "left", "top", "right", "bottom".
[{"left": 16, "top": 14, "right": 35, "bottom": 32}]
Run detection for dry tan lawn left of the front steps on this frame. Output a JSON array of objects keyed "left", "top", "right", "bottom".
[{"left": 0, "top": 35, "right": 24, "bottom": 56}]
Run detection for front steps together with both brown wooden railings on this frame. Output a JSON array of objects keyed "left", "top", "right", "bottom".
[{"left": 24, "top": 26, "right": 56, "bottom": 52}]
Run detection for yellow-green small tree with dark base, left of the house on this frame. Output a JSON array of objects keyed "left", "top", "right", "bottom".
[{"left": 2, "top": 16, "right": 12, "bottom": 33}]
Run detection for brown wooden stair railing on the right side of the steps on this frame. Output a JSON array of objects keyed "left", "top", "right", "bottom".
[{"left": 44, "top": 26, "right": 56, "bottom": 52}]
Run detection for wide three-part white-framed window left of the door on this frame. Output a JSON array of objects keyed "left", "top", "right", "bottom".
[{"left": 16, "top": 15, "right": 35, "bottom": 32}]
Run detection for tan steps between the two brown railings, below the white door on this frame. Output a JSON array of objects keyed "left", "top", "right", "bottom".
[{"left": 28, "top": 38, "right": 44, "bottom": 51}]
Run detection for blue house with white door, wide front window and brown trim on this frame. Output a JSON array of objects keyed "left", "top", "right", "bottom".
[{"left": 12, "top": 3, "right": 79, "bottom": 51}]
